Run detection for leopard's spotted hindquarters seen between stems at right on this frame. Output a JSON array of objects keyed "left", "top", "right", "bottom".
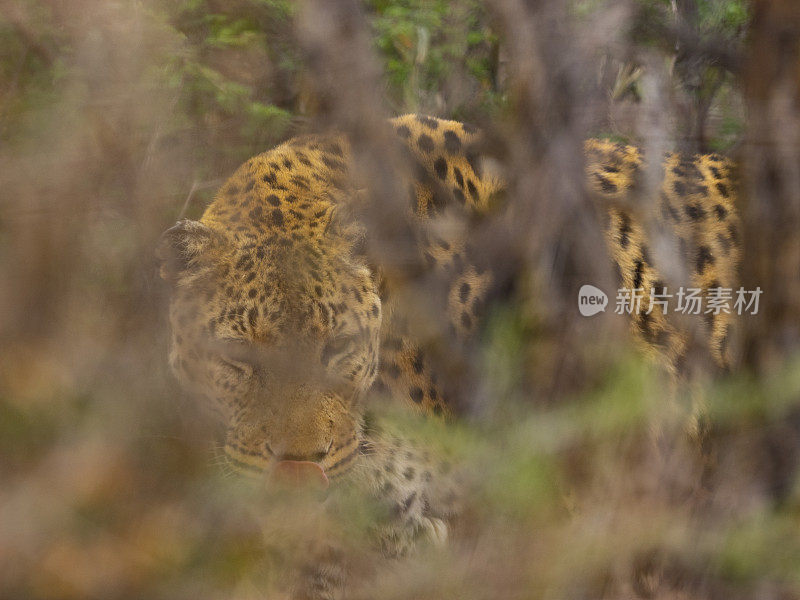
[{"left": 586, "top": 140, "right": 741, "bottom": 375}]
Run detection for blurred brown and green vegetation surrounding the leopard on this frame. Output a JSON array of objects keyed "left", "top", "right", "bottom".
[{"left": 0, "top": 0, "right": 800, "bottom": 599}]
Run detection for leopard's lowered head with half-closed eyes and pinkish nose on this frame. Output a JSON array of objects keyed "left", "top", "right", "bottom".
[{"left": 158, "top": 220, "right": 381, "bottom": 477}]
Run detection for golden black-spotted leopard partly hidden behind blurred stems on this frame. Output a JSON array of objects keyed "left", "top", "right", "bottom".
[{"left": 157, "top": 114, "right": 740, "bottom": 597}]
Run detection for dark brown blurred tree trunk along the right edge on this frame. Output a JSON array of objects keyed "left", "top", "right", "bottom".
[{"left": 742, "top": 0, "right": 800, "bottom": 371}]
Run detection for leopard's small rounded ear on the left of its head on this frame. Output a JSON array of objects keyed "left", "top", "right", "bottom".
[{"left": 156, "top": 219, "right": 219, "bottom": 282}]
